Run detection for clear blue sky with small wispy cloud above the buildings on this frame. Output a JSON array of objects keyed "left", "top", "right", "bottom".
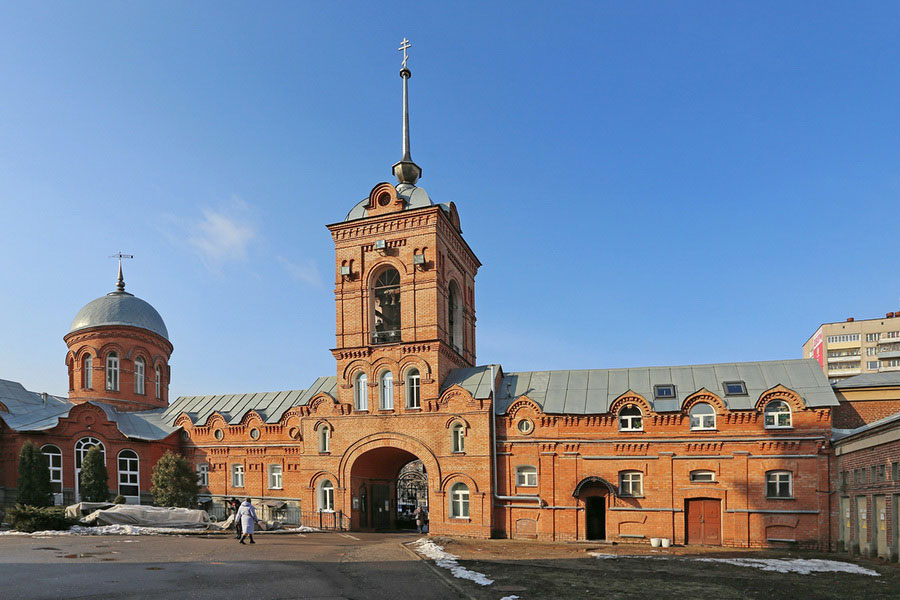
[{"left": 0, "top": 2, "right": 900, "bottom": 398}]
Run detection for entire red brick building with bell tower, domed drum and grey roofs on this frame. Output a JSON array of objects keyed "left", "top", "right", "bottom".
[{"left": 0, "top": 58, "right": 856, "bottom": 548}]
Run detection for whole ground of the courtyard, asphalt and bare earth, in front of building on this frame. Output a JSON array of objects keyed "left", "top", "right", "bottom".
[{"left": 0, "top": 533, "right": 900, "bottom": 600}]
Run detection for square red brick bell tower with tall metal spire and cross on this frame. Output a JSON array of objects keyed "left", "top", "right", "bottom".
[{"left": 328, "top": 39, "right": 481, "bottom": 413}]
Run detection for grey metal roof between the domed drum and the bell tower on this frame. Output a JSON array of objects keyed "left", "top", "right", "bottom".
[{"left": 162, "top": 376, "right": 337, "bottom": 425}]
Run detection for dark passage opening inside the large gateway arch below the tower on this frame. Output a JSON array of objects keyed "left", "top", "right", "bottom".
[{"left": 350, "top": 448, "right": 428, "bottom": 530}]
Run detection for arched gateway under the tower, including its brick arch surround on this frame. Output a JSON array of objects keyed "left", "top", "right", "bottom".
[{"left": 341, "top": 434, "right": 440, "bottom": 530}]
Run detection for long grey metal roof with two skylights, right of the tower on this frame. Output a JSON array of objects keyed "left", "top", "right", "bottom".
[{"left": 444, "top": 359, "right": 838, "bottom": 414}]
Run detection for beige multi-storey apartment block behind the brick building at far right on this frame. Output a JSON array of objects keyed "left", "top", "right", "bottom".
[{"left": 803, "top": 311, "right": 900, "bottom": 383}]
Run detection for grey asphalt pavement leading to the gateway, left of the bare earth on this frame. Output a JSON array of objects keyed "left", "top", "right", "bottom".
[{"left": 0, "top": 532, "right": 459, "bottom": 600}]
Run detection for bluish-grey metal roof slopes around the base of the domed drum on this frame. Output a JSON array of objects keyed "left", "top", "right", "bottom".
[{"left": 0, "top": 379, "right": 175, "bottom": 440}]
